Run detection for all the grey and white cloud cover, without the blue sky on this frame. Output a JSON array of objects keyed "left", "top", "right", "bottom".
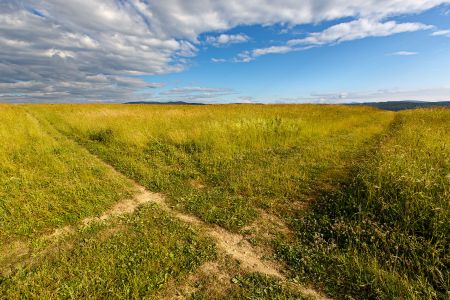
[{"left": 0, "top": 0, "right": 450, "bottom": 101}]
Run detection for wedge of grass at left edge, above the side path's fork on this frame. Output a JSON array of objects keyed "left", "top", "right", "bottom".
[{"left": 0, "top": 105, "right": 132, "bottom": 244}]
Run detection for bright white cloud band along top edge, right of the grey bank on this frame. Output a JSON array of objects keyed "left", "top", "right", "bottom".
[{"left": 139, "top": 0, "right": 450, "bottom": 40}]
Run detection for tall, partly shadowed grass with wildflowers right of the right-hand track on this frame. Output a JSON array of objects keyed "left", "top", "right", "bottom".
[{"left": 278, "top": 109, "right": 450, "bottom": 299}]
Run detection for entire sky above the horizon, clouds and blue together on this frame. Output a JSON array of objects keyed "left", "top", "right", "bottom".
[{"left": 0, "top": 0, "right": 450, "bottom": 103}]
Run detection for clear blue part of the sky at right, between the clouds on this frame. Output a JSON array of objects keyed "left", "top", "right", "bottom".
[{"left": 144, "top": 6, "right": 450, "bottom": 102}]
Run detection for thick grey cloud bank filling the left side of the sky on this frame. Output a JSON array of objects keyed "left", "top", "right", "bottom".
[{"left": 0, "top": 1, "right": 190, "bottom": 102}]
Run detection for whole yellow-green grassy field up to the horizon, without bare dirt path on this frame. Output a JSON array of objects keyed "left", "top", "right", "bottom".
[{"left": 0, "top": 105, "right": 450, "bottom": 299}]
